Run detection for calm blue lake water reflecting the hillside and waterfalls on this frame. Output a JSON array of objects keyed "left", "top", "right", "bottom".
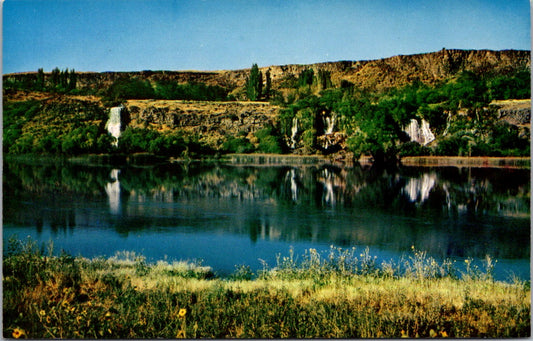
[{"left": 3, "top": 158, "right": 530, "bottom": 280}]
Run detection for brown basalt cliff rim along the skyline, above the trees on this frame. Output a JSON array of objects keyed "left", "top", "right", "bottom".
[{"left": 4, "top": 49, "right": 531, "bottom": 91}]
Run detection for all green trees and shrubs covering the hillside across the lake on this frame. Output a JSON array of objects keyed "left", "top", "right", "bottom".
[{"left": 3, "top": 64, "right": 531, "bottom": 163}]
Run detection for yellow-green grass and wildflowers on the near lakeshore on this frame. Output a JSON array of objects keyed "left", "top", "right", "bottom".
[{"left": 3, "top": 241, "right": 531, "bottom": 339}]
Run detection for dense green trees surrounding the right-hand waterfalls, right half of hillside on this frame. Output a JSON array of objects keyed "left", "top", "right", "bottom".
[{"left": 281, "top": 70, "right": 530, "bottom": 161}]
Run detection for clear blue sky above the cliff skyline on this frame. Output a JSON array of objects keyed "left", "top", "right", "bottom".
[{"left": 2, "top": 0, "right": 531, "bottom": 73}]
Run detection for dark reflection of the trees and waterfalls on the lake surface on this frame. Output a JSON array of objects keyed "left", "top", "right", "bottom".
[{"left": 3, "top": 162, "right": 530, "bottom": 257}]
